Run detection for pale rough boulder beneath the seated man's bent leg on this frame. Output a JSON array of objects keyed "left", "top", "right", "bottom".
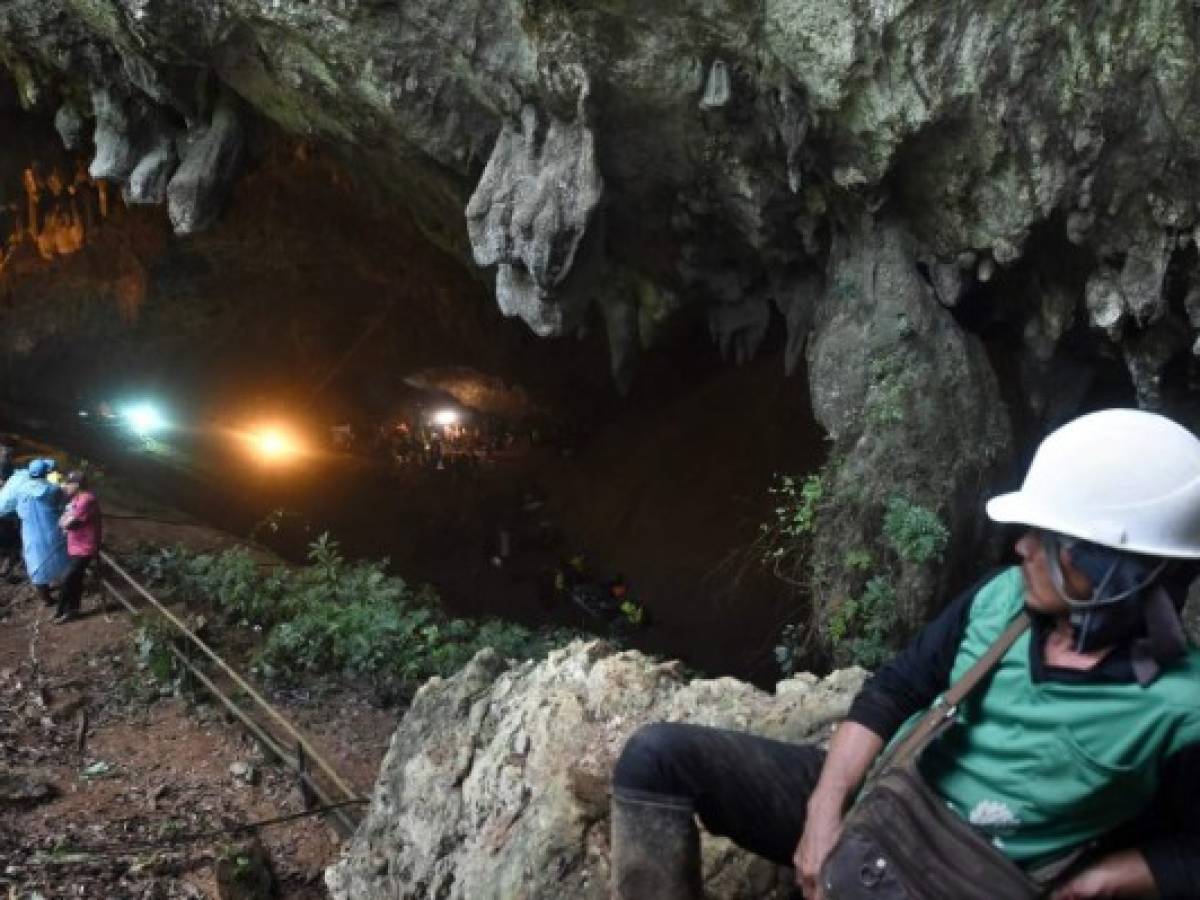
[{"left": 325, "top": 642, "right": 864, "bottom": 900}]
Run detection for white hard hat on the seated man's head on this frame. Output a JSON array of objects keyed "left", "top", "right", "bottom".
[{"left": 988, "top": 409, "right": 1200, "bottom": 559}]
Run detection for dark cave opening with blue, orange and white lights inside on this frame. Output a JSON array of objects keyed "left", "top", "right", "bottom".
[{"left": 0, "top": 91, "right": 826, "bottom": 684}]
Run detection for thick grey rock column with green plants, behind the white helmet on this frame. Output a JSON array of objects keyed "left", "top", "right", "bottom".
[{"left": 808, "top": 220, "right": 1012, "bottom": 652}]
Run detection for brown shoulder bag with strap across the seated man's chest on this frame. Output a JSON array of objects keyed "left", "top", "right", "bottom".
[{"left": 821, "top": 613, "right": 1066, "bottom": 900}]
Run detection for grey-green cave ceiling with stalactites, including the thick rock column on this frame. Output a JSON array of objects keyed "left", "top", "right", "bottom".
[{"left": 0, "top": 0, "right": 1200, "bottom": 648}]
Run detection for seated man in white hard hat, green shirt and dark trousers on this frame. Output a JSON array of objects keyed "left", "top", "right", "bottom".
[{"left": 612, "top": 409, "right": 1200, "bottom": 900}]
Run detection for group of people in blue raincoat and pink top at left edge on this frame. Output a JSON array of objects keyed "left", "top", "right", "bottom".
[{"left": 0, "top": 446, "right": 103, "bottom": 624}]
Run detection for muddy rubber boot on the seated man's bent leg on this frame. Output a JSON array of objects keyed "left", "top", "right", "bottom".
[{"left": 612, "top": 787, "right": 703, "bottom": 900}]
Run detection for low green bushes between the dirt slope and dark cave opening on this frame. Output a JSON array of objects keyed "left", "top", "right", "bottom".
[{"left": 134, "top": 534, "right": 574, "bottom": 688}]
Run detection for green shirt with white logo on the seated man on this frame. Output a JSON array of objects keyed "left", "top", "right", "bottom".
[{"left": 901, "top": 568, "right": 1200, "bottom": 864}]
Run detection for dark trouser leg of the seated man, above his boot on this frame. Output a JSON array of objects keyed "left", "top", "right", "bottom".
[{"left": 612, "top": 724, "right": 824, "bottom": 878}]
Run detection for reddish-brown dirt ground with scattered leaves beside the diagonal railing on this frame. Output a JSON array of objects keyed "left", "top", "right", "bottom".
[{"left": 0, "top": 520, "right": 397, "bottom": 900}]
